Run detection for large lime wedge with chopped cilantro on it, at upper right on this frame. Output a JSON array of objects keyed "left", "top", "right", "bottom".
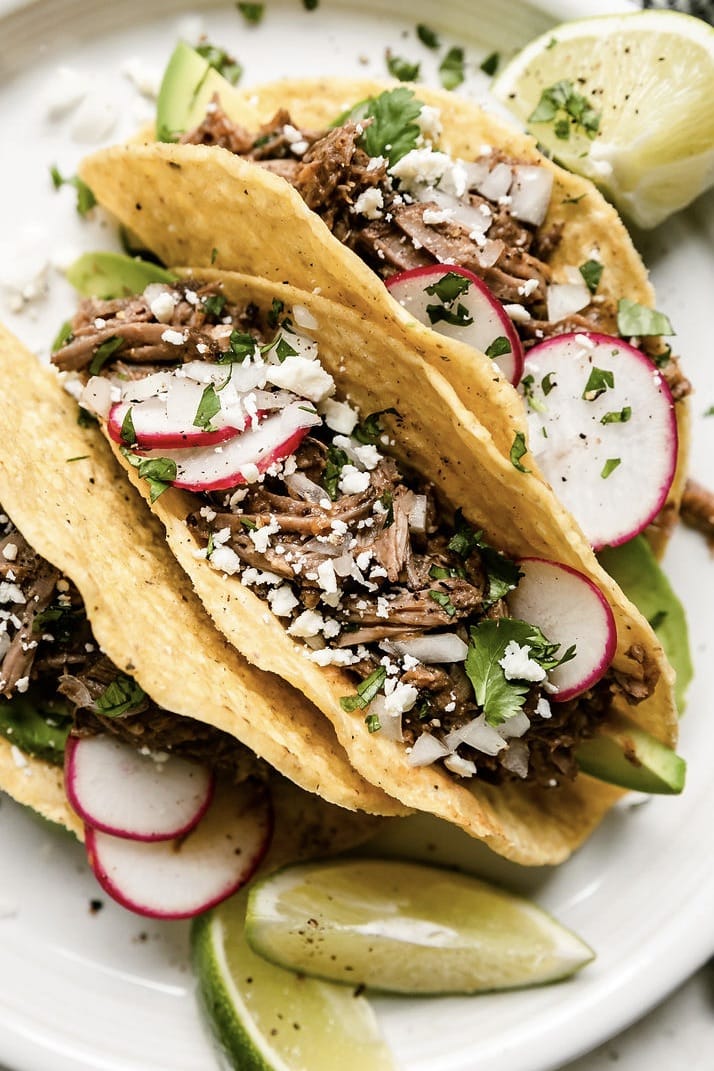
[{"left": 492, "top": 11, "right": 714, "bottom": 227}]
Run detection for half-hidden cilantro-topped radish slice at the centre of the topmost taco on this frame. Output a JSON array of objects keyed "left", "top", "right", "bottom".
[{"left": 386, "top": 265, "right": 523, "bottom": 384}]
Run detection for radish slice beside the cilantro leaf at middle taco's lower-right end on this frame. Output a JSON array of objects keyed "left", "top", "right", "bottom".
[{"left": 507, "top": 558, "right": 618, "bottom": 703}]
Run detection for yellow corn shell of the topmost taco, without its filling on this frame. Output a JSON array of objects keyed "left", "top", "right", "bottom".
[{"left": 80, "top": 78, "right": 689, "bottom": 554}]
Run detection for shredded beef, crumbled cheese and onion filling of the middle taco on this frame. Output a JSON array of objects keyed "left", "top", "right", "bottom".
[{"left": 52, "top": 281, "right": 658, "bottom": 786}]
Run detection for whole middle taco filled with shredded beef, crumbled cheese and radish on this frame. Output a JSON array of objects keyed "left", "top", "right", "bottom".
[{"left": 44, "top": 261, "right": 677, "bottom": 863}]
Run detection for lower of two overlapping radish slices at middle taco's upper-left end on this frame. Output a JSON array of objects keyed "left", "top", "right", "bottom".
[{"left": 134, "top": 402, "right": 321, "bottom": 492}]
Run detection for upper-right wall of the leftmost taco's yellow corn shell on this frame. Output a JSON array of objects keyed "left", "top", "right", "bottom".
[{"left": 0, "top": 328, "right": 405, "bottom": 814}]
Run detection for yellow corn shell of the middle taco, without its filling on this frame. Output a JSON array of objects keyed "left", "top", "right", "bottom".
[{"left": 72, "top": 270, "right": 677, "bottom": 864}]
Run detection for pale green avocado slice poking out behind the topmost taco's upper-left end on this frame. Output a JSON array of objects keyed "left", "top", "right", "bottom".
[{"left": 156, "top": 41, "right": 246, "bottom": 141}]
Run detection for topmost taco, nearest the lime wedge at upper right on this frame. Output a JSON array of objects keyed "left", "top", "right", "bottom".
[{"left": 81, "top": 61, "right": 689, "bottom": 554}]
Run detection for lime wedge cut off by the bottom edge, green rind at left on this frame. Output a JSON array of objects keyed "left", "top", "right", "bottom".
[{"left": 192, "top": 892, "right": 395, "bottom": 1071}]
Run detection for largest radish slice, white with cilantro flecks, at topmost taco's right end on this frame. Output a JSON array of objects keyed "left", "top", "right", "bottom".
[{"left": 521, "top": 334, "right": 678, "bottom": 549}]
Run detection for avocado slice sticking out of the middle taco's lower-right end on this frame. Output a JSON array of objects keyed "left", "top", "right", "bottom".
[{"left": 577, "top": 715, "right": 686, "bottom": 796}]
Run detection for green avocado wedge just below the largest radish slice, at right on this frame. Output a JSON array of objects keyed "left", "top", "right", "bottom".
[{"left": 597, "top": 536, "right": 694, "bottom": 713}]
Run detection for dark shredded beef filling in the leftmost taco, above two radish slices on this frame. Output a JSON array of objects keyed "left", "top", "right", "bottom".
[{"left": 0, "top": 508, "right": 263, "bottom": 782}]
